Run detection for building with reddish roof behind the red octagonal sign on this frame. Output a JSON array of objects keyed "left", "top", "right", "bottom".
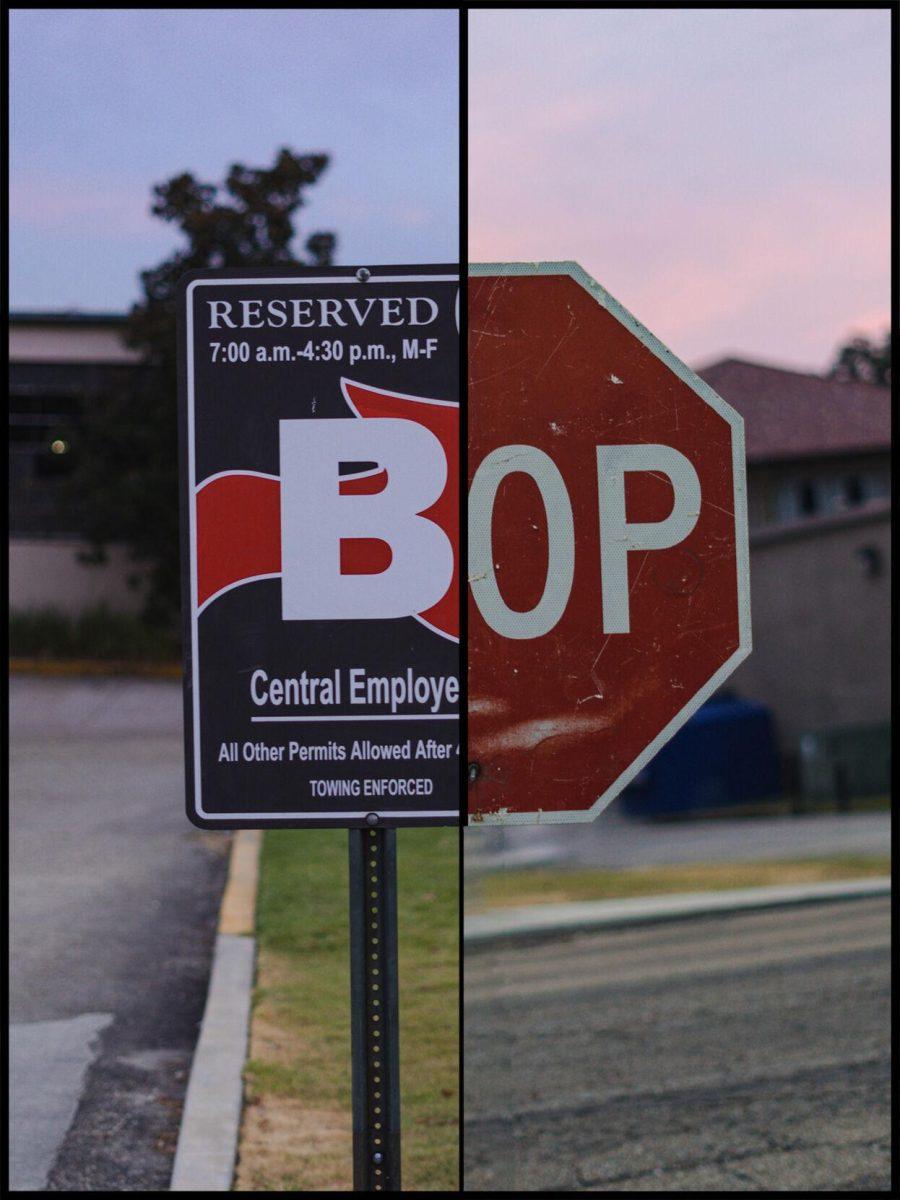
[{"left": 698, "top": 359, "right": 890, "bottom": 757}]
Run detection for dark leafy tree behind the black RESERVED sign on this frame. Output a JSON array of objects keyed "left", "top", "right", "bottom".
[{"left": 67, "top": 149, "right": 336, "bottom": 625}]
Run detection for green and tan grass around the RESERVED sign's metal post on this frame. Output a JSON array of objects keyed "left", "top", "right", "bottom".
[{"left": 239, "top": 829, "right": 460, "bottom": 1190}]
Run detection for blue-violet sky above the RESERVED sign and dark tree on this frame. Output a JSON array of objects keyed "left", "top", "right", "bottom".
[{"left": 10, "top": 8, "right": 460, "bottom": 311}]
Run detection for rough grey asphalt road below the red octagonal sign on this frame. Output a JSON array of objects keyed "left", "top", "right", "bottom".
[{"left": 463, "top": 899, "right": 890, "bottom": 1193}]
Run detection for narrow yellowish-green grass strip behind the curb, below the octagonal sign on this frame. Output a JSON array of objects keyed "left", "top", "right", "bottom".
[{"left": 466, "top": 854, "right": 890, "bottom": 913}]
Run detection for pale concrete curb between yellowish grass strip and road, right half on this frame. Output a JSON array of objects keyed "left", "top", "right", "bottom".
[{"left": 463, "top": 876, "right": 890, "bottom": 949}]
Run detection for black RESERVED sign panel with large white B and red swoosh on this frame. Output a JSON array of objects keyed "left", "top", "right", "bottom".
[{"left": 179, "top": 266, "right": 461, "bottom": 829}]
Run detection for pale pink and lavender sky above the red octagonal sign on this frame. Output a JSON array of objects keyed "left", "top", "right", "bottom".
[{"left": 469, "top": 8, "right": 890, "bottom": 371}]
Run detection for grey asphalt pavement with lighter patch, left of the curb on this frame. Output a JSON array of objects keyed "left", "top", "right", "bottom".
[{"left": 10, "top": 678, "right": 227, "bottom": 1192}]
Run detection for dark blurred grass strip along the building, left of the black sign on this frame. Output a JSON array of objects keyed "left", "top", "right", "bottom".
[{"left": 10, "top": 605, "right": 181, "bottom": 662}]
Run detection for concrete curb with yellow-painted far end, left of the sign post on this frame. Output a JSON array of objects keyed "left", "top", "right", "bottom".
[{"left": 169, "top": 829, "right": 263, "bottom": 1192}]
